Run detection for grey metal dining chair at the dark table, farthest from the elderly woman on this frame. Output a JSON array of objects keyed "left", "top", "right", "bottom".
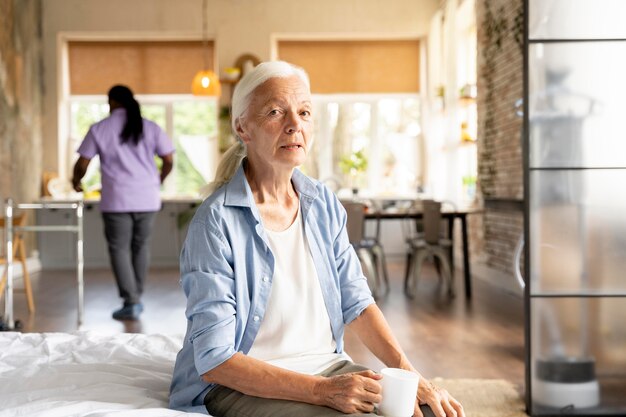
[{"left": 404, "top": 200, "right": 455, "bottom": 298}]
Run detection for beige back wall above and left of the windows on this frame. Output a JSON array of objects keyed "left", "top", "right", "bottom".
[{"left": 43, "top": 0, "right": 438, "bottom": 171}]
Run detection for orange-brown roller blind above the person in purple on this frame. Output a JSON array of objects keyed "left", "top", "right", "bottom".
[{"left": 69, "top": 41, "right": 213, "bottom": 94}]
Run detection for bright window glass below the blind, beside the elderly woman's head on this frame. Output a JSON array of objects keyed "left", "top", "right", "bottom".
[{"left": 303, "top": 94, "right": 424, "bottom": 195}]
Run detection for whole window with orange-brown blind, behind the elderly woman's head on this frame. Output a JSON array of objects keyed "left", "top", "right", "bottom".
[{"left": 276, "top": 38, "right": 425, "bottom": 196}]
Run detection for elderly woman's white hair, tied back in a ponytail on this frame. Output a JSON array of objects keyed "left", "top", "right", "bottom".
[{"left": 201, "top": 61, "right": 311, "bottom": 196}]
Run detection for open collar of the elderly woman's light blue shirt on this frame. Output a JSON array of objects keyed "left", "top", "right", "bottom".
[{"left": 224, "top": 162, "right": 319, "bottom": 207}]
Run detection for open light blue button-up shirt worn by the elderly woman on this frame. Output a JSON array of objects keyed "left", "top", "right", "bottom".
[{"left": 170, "top": 166, "right": 374, "bottom": 413}]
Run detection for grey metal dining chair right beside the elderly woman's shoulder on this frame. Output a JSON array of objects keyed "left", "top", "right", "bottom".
[{"left": 341, "top": 201, "right": 389, "bottom": 298}]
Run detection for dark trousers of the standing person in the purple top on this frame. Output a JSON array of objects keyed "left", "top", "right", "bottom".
[{"left": 102, "top": 212, "right": 156, "bottom": 305}]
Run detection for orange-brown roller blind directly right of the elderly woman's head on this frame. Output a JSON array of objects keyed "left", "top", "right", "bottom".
[{"left": 278, "top": 40, "right": 420, "bottom": 94}]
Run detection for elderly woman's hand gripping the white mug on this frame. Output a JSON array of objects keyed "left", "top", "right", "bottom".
[{"left": 315, "top": 370, "right": 382, "bottom": 414}]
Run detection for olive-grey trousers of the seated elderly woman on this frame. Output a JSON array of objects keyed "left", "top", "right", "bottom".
[{"left": 204, "top": 361, "right": 434, "bottom": 417}]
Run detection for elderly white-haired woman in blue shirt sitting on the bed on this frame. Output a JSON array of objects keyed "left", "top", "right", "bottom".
[{"left": 170, "top": 61, "right": 464, "bottom": 417}]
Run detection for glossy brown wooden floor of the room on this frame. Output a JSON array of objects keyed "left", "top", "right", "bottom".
[{"left": 2, "top": 262, "right": 524, "bottom": 389}]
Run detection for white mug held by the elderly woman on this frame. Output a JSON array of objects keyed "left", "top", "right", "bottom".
[{"left": 378, "top": 368, "right": 420, "bottom": 417}]
